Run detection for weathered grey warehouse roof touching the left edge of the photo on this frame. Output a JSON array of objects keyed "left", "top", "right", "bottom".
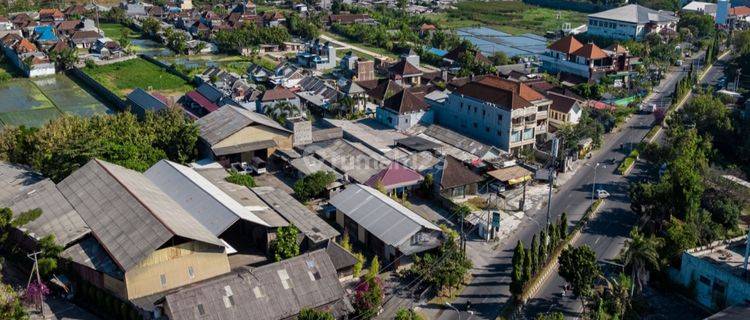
[{"left": 0, "top": 161, "right": 90, "bottom": 246}]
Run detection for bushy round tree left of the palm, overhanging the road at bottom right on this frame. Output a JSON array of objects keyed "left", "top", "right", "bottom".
[{"left": 557, "top": 245, "right": 601, "bottom": 306}]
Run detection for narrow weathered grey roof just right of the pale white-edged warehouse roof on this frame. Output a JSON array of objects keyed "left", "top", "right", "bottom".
[{"left": 252, "top": 187, "right": 339, "bottom": 243}]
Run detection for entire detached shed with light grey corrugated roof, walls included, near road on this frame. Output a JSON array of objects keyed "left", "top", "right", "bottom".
[{"left": 330, "top": 184, "right": 442, "bottom": 270}]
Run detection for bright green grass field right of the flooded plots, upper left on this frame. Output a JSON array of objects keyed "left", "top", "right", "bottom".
[{"left": 82, "top": 58, "right": 193, "bottom": 97}]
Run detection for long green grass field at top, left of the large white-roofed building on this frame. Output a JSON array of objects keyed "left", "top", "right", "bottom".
[{"left": 432, "top": 1, "right": 587, "bottom": 35}]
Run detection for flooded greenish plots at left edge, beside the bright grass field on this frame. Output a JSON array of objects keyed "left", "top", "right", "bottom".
[{"left": 0, "top": 74, "right": 110, "bottom": 127}]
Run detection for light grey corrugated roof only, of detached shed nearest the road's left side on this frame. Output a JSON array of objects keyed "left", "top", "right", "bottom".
[{"left": 330, "top": 184, "right": 440, "bottom": 247}]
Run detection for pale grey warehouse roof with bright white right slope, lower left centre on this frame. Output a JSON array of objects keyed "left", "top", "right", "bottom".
[{"left": 145, "top": 160, "right": 268, "bottom": 236}]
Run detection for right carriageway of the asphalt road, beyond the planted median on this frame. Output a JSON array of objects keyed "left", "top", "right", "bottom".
[{"left": 524, "top": 52, "right": 729, "bottom": 318}]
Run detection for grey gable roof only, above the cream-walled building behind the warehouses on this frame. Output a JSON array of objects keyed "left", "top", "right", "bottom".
[{"left": 196, "top": 105, "right": 290, "bottom": 145}]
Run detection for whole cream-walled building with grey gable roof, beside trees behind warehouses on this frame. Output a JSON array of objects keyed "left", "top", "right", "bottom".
[{"left": 196, "top": 105, "right": 292, "bottom": 167}]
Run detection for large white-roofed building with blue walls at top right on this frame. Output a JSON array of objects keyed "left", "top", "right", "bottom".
[{"left": 587, "top": 4, "right": 679, "bottom": 40}]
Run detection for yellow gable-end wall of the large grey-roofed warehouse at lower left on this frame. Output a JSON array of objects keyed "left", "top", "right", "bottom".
[{"left": 125, "top": 241, "right": 230, "bottom": 299}]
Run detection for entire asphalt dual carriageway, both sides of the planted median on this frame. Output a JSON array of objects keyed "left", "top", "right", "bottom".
[{"left": 427, "top": 57, "right": 704, "bottom": 320}]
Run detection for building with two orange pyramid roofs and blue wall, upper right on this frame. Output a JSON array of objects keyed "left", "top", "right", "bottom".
[{"left": 539, "top": 35, "right": 633, "bottom": 81}]
